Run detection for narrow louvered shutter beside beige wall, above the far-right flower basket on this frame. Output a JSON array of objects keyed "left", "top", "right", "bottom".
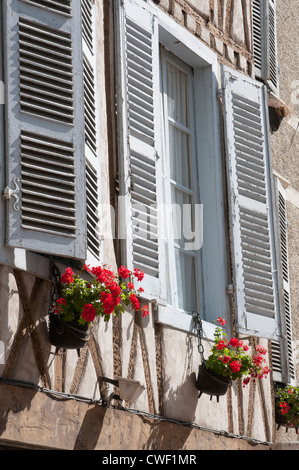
[{"left": 271, "top": 178, "right": 295, "bottom": 383}]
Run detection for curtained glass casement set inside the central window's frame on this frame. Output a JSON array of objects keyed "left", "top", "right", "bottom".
[{"left": 161, "top": 51, "right": 200, "bottom": 312}]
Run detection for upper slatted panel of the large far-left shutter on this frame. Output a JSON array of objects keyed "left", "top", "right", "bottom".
[{"left": 19, "top": 18, "right": 74, "bottom": 124}]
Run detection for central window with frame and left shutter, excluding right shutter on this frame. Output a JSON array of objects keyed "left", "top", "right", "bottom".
[{"left": 116, "top": 0, "right": 229, "bottom": 330}]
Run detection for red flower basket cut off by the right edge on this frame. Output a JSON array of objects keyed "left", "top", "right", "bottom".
[{"left": 275, "top": 385, "right": 299, "bottom": 434}]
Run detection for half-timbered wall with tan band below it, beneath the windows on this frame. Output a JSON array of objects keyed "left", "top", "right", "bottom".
[{"left": 0, "top": 266, "right": 274, "bottom": 449}]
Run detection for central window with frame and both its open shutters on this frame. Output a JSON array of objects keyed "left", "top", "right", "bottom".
[{"left": 116, "top": 0, "right": 288, "bottom": 346}]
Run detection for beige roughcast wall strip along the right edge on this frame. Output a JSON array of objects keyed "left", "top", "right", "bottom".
[{"left": 271, "top": 0, "right": 299, "bottom": 441}]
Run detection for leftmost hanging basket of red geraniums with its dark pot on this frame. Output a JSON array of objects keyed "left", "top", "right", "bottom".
[{"left": 49, "top": 265, "right": 149, "bottom": 350}]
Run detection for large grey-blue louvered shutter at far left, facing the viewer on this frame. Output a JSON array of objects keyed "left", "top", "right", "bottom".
[{"left": 3, "top": 0, "right": 86, "bottom": 259}]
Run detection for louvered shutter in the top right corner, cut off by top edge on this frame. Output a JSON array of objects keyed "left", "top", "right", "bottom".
[{"left": 252, "top": 0, "right": 278, "bottom": 93}]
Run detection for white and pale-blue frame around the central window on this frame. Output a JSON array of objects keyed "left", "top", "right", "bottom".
[{"left": 115, "top": 0, "right": 231, "bottom": 339}]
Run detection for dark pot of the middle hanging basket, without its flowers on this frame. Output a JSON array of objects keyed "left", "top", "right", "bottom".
[{"left": 196, "top": 362, "right": 232, "bottom": 400}]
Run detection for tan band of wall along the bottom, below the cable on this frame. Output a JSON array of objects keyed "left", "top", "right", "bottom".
[{"left": 0, "top": 386, "right": 270, "bottom": 454}]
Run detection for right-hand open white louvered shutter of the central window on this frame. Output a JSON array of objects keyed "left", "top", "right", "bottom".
[{"left": 223, "top": 68, "right": 279, "bottom": 339}]
